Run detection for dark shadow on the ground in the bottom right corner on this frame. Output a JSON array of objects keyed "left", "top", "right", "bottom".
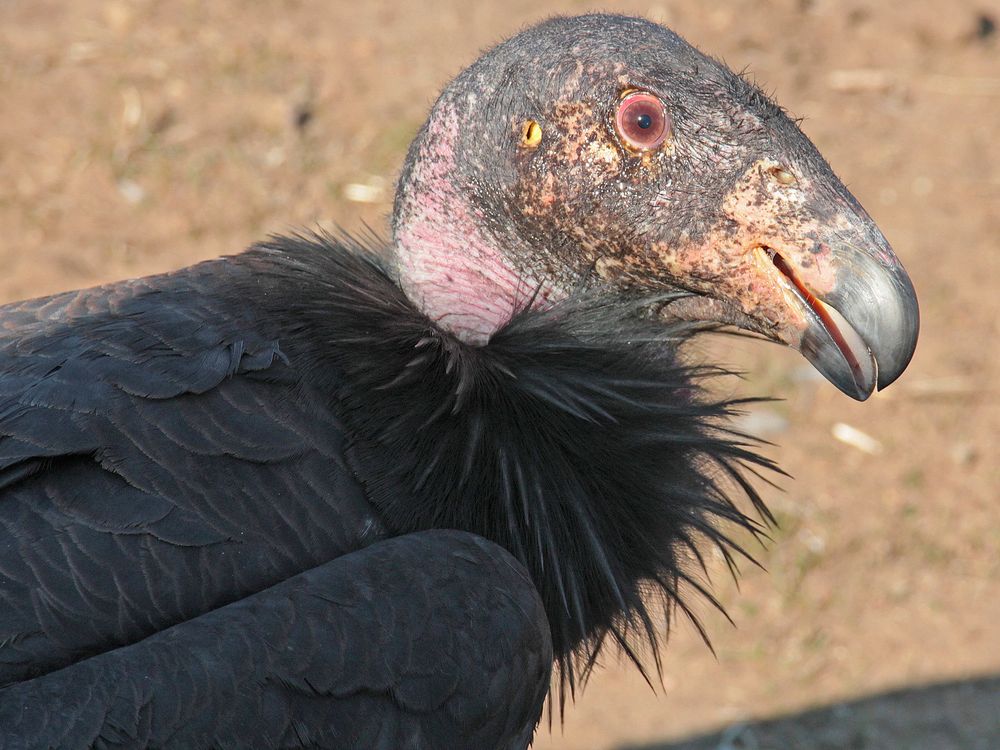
[{"left": 620, "top": 676, "right": 1000, "bottom": 750}]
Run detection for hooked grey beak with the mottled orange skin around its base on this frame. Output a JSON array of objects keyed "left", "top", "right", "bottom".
[{"left": 660, "top": 162, "right": 920, "bottom": 401}]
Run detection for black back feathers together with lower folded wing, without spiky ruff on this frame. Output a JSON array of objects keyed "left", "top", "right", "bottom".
[{"left": 0, "top": 241, "right": 553, "bottom": 750}]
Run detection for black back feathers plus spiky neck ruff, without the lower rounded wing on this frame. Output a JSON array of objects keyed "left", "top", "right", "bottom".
[{"left": 0, "top": 242, "right": 762, "bottom": 712}]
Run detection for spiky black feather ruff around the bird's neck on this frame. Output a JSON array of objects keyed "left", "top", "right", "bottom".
[{"left": 244, "top": 240, "right": 768, "bottom": 708}]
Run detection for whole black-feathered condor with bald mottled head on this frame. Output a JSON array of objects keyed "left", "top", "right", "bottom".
[{"left": 0, "top": 11, "right": 915, "bottom": 748}]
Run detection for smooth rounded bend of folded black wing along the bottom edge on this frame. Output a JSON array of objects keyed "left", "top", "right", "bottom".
[{"left": 0, "top": 531, "right": 552, "bottom": 750}]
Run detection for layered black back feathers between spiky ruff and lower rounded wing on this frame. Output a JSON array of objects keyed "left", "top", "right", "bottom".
[{"left": 0, "top": 259, "right": 379, "bottom": 685}]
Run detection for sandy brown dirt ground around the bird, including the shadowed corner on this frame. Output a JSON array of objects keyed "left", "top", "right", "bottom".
[{"left": 0, "top": 0, "right": 1000, "bottom": 750}]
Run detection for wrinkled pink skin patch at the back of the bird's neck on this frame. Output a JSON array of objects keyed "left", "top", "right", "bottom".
[{"left": 394, "top": 102, "right": 537, "bottom": 344}]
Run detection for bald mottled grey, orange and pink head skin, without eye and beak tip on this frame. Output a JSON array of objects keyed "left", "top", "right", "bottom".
[{"left": 394, "top": 16, "right": 916, "bottom": 362}]
